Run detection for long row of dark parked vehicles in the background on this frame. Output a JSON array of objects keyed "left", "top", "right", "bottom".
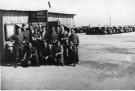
[{"left": 82, "top": 26, "right": 135, "bottom": 34}]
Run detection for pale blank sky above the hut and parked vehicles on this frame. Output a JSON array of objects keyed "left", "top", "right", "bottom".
[{"left": 0, "top": 0, "right": 135, "bottom": 26}]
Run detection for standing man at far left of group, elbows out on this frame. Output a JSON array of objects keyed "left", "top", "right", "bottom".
[{"left": 9, "top": 28, "right": 28, "bottom": 68}]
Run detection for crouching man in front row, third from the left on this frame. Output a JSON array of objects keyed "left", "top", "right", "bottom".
[{"left": 53, "top": 41, "right": 64, "bottom": 66}]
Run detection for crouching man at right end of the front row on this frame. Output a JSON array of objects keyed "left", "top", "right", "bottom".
[{"left": 68, "top": 41, "right": 77, "bottom": 66}]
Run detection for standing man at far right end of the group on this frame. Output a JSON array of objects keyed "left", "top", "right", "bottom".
[{"left": 69, "top": 29, "right": 80, "bottom": 64}]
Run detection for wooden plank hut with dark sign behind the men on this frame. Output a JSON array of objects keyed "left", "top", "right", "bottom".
[{"left": 0, "top": 9, "right": 75, "bottom": 61}]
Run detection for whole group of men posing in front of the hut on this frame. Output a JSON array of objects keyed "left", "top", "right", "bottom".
[{"left": 9, "top": 24, "right": 79, "bottom": 68}]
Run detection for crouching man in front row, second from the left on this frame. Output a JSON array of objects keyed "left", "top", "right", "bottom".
[{"left": 40, "top": 41, "right": 52, "bottom": 64}]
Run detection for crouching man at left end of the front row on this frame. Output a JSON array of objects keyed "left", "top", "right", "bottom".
[{"left": 22, "top": 42, "right": 39, "bottom": 67}]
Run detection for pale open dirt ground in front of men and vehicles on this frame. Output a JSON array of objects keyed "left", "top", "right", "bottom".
[{"left": 1, "top": 32, "right": 135, "bottom": 90}]
